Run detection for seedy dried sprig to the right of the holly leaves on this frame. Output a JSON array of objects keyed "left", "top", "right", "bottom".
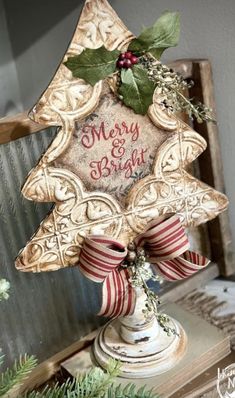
[{"left": 139, "top": 54, "right": 216, "bottom": 123}]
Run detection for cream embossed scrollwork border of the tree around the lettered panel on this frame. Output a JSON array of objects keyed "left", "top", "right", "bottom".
[{"left": 16, "top": 0, "right": 227, "bottom": 272}]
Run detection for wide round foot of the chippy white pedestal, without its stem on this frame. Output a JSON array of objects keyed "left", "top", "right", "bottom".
[{"left": 93, "top": 318, "right": 187, "bottom": 379}]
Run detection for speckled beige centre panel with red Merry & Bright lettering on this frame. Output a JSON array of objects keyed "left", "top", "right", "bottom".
[{"left": 55, "top": 91, "right": 172, "bottom": 202}]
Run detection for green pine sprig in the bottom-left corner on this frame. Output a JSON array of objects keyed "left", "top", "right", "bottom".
[{"left": 0, "top": 355, "right": 37, "bottom": 397}]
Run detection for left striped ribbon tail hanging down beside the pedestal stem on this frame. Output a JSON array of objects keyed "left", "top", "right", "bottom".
[{"left": 98, "top": 269, "right": 136, "bottom": 318}]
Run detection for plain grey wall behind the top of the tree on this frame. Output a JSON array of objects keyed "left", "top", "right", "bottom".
[{"left": 0, "top": 0, "right": 235, "bottom": 249}]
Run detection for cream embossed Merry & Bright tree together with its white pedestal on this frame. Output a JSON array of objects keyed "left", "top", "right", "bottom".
[{"left": 12, "top": 0, "right": 227, "bottom": 384}]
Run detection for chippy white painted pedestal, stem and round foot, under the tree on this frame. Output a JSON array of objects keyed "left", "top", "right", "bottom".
[{"left": 93, "top": 288, "right": 187, "bottom": 379}]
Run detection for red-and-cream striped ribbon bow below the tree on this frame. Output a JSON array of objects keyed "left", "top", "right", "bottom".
[{"left": 80, "top": 214, "right": 209, "bottom": 317}]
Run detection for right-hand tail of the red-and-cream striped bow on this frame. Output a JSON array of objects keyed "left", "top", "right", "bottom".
[{"left": 153, "top": 250, "right": 210, "bottom": 282}]
